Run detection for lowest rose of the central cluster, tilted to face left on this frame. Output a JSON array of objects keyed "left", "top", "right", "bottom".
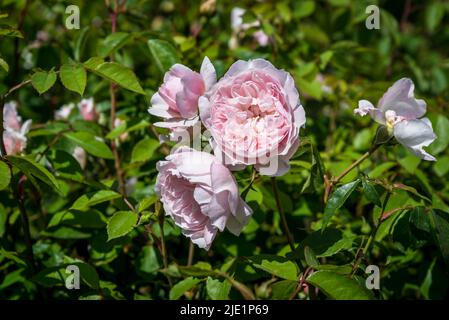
[{"left": 155, "top": 147, "right": 252, "bottom": 250}]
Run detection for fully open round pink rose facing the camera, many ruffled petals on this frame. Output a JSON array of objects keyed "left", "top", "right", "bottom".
[{"left": 199, "top": 59, "right": 306, "bottom": 176}]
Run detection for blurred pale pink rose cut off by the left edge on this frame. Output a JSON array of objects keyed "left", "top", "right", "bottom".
[{"left": 3, "top": 101, "right": 31, "bottom": 155}]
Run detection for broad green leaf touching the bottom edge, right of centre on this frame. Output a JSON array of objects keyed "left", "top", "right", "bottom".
[{"left": 307, "top": 271, "right": 374, "bottom": 300}]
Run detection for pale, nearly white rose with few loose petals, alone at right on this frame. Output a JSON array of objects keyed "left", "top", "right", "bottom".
[{"left": 354, "top": 78, "right": 436, "bottom": 161}]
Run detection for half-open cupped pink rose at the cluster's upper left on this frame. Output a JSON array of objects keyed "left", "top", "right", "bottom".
[{"left": 148, "top": 57, "right": 217, "bottom": 141}]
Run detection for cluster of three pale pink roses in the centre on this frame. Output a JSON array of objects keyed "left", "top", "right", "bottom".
[{"left": 148, "top": 57, "right": 306, "bottom": 249}]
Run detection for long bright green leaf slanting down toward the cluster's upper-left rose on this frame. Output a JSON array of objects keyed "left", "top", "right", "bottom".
[{"left": 84, "top": 58, "right": 145, "bottom": 95}]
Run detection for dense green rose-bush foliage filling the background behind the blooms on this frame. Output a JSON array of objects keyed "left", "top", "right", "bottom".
[{"left": 0, "top": 0, "right": 449, "bottom": 299}]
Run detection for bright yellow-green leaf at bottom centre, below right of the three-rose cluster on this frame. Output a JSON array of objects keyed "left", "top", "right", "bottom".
[{"left": 248, "top": 254, "right": 298, "bottom": 281}]
